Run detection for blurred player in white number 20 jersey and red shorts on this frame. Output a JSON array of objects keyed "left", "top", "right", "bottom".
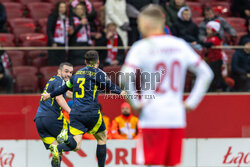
[{"left": 122, "top": 5, "right": 213, "bottom": 166}]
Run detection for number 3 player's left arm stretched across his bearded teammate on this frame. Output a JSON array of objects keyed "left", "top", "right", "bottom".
[{"left": 42, "top": 79, "right": 73, "bottom": 101}]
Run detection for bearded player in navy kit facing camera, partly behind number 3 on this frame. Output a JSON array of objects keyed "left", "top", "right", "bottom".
[{"left": 34, "top": 63, "right": 73, "bottom": 167}]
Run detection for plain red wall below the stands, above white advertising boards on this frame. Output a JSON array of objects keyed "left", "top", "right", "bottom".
[{"left": 0, "top": 94, "right": 250, "bottom": 139}]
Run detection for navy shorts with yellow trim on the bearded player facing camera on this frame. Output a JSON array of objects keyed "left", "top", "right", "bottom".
[{"left": 35, "top": 117, "right": 63, "bottom": 149}]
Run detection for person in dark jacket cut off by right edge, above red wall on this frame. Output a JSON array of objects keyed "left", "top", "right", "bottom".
[{"left": 232, "top": 38, "right": 250, "bottom": 91}]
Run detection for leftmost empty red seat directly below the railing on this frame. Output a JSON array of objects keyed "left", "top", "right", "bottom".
[{"left": 7, "top": 51, "right": 25, "bottom": 67}]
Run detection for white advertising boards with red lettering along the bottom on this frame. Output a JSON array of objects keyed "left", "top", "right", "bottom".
[{"left": 0, "top": 138, "right": 250, "bottom": 167}]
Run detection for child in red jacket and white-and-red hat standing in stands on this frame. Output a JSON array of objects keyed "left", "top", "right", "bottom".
[{"left": 204, "top": 21, "right": 227, "bottom": 91}]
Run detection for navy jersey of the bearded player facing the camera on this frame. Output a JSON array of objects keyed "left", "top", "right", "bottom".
[{"left": 36, "top": 76, "right": 66, "bottom": 118}]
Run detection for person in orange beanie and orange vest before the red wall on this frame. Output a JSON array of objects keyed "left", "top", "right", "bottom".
[{"left": 111, "top": 102, "right": 138, "bottom": 139}]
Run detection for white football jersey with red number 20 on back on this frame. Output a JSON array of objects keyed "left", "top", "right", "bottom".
[{"left": 122, "top": 35, "right": 213, "bottom": 128}]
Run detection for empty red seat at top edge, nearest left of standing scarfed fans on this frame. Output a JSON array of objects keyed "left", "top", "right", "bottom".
[{"left": 27, "top": 2, "right": 53, "bottom": 21}]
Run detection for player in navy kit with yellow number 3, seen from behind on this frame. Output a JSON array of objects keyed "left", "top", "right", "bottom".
[{"left": 42, "top": 51, "right": 125, "bottom": 167}]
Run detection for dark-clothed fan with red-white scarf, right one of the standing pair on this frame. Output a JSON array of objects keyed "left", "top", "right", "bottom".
[{"left": 68, "top": 3, "right": 92, "bottom": 66}]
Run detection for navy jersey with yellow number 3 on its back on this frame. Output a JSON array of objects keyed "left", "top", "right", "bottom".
[{"left": 62, "top": 66, "right": 121, "bottom": 114}]
